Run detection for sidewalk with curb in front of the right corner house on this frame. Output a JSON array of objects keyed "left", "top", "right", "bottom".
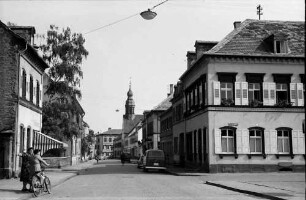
[{"left": 167, "top": 166, "right": 305, "bottom": 200}]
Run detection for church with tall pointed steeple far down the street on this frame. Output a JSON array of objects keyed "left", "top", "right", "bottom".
[{"left": 121, "top": 83, "right": 143, "bottom": 153}]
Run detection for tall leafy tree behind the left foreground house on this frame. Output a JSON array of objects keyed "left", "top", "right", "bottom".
[{"left": 40, "top": 25, "right": 88, "bottom": 140}]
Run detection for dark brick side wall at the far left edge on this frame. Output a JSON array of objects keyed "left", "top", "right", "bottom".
[{"left": 0, "top": 27, "right": 18, "bottom": 132}]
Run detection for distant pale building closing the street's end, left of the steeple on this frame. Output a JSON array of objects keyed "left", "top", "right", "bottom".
[{"left": 96, "top": 128, "right": 122, "bottom": 157}]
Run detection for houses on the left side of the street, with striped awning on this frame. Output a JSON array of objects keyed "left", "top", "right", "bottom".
[{"left": 0, "top": 21, "right": 85, "bottom": 178}]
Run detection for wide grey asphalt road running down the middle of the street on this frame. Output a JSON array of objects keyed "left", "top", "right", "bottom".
[{"left": 29, "top": 160, "right": 259, "bottom": 200}]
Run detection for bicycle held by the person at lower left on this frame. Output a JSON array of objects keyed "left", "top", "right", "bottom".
[{"left": 31, "top": 171, "right": 51, "bottom": 197}]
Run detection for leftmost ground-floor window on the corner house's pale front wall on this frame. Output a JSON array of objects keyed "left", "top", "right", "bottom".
[{"left": 221, "top": 129, "right": 235, "bottom": 153}]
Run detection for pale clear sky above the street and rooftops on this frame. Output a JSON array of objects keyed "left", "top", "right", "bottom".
[{"left": 0, "top": 0, "right": 305, "bottom": 132}]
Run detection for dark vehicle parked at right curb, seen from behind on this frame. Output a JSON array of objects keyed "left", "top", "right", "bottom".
[{"left": 143, "top": 149, "right": 166, "bottom": 172}]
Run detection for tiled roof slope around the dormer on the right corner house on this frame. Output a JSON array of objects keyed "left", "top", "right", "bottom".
[{"left": 205, "top": 19, "right": 305, "bottom": 57}]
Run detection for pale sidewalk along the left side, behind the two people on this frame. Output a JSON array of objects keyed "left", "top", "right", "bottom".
[{"left": 0, "top": 160, "right": 96, "bottom": 200}]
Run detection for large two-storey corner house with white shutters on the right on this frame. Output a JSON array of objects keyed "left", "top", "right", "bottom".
[{"left": 173, "top": 20, "right": 305, "bottom": 172}]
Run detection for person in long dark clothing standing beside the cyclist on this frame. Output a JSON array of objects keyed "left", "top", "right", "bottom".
[{"left": 18, "top": 147, "right": 34, "bottom": 192}]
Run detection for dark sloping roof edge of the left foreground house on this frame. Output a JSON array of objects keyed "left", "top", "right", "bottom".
[{"left": 0, "top": 20, "right": 49, "bottom": 70}]
